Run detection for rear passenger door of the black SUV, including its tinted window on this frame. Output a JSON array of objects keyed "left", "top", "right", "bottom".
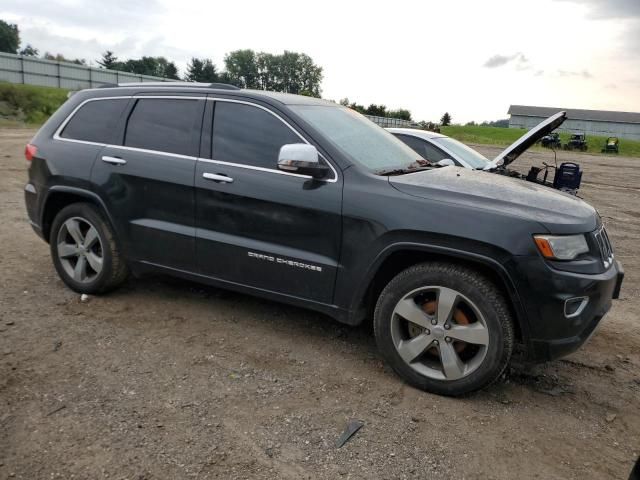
[{"left": 92, "top": 97, "right": 205, "bottom": 270}]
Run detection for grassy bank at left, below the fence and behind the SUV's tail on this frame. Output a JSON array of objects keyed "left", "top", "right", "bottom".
[{"left": 0, "top": 82, "right": 68, "bottom": 125}]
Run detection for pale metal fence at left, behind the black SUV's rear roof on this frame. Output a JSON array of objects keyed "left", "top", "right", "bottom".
[{"left": 0, "top": 52, "right": 175, "bottom": 90}]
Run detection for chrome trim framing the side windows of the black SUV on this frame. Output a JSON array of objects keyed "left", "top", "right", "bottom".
[{"left": 53, "top": 94, "right": 338, "bottom": 183}]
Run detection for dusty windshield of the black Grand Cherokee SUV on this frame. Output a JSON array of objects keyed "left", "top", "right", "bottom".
[{"left": 290, "top": 105, "right": 424, "bottom": 171}]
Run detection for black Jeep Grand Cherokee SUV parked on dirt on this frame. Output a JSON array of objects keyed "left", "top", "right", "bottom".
[{"left": 25, "top": 84, "right": 623, "bottom": 395}]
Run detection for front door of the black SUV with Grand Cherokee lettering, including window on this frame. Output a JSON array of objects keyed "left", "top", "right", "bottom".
[{"left": 195, "top": 100, "right": 342, "bottom": 303}]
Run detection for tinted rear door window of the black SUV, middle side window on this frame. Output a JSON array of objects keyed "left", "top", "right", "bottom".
[{"left": 124, "top": 98, "right": 203, "bottom": 157}]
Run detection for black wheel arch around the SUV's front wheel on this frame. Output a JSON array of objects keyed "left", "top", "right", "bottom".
[{"left": 348, "top": 243, "right": 529, "bottom": 343}]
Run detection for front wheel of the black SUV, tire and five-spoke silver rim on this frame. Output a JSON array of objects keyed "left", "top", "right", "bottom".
[{"left": 374, "top": 263, "right": 514, "bottom": 396}]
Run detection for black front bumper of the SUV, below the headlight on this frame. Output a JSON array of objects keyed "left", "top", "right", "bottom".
[{"left": 518, "top": 257, "right": 624, "bottom": 362}]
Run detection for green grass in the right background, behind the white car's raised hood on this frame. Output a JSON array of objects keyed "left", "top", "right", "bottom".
[{"left": 440, "top": 125, "right": 640, "bottom": 157}]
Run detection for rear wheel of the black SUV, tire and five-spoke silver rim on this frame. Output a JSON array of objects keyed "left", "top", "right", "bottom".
[{"left": 49, "top": 203, "right": 129, "bottom": 294}]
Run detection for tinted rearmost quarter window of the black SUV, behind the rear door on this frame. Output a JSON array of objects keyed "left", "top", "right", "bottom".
[{"left": 60, "top": 98, "right": 129, "bottom": 143}]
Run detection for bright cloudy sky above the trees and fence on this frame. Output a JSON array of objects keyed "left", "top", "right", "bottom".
[{"left": 0, "top": 0, "right": 640, "bottom": 123}]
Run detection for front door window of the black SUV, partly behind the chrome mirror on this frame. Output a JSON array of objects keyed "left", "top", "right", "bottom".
[{"left": 213, "top": 102, "right": 304, "bottom": 169}]
